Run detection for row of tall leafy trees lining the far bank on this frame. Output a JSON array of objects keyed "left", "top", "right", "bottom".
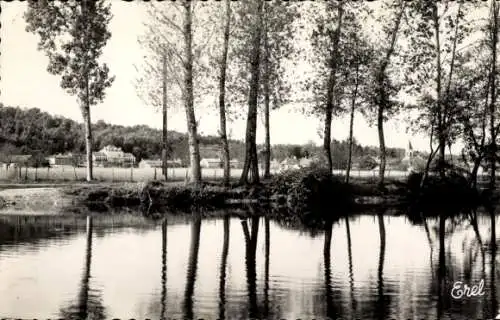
[{"left": 21, "top": 0, "right": 500, "bottom": 188}]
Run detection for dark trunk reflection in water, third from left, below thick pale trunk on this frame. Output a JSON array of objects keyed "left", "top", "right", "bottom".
[{"left": 183, "top": 215, "right": 201, "bottom": 319}]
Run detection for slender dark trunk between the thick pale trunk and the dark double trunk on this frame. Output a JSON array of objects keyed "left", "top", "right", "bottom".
[{"left": 219, "top": 0, "right": 231, "bottom": 186}]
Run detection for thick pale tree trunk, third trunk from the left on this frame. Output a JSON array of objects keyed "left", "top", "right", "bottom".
[{"left": 183, "top": 1, "right": 201, "bottom": 186}]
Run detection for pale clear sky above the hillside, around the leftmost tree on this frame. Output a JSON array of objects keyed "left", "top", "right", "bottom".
[{"left": 0, "top": 0, "right": 436, "bottom": 151}]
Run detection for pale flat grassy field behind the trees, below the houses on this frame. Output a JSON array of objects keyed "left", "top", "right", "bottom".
[{"left": 0, "top": 166, "right": 408, "bottom": 182}]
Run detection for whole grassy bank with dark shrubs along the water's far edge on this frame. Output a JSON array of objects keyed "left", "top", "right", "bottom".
[{"left": 0, "top": 168, "right": 484, "bottom": 229}]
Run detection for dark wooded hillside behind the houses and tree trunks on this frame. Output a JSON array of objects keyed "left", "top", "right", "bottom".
[{"left": 0, "top": 103, "right": 404, "bottom": 167}]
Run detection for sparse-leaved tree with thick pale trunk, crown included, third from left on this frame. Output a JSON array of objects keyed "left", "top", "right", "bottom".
[{"left": 138, "top": 1, "right": 215, "bottom": 184}]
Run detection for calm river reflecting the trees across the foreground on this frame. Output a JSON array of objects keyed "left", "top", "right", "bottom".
[{"left": 0, "top": 209, "right": 499, "bottom": 320}]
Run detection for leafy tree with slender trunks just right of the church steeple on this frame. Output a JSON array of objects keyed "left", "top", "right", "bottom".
[{"left": 405, "top": 1, "right": 475, "bottom": 184}]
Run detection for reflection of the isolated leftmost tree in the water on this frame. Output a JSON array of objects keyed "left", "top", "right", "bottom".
[{"left": 60, "top": 216, "right": 106, "bottom": 319}]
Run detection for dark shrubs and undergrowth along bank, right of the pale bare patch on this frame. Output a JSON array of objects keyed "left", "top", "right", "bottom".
[{"left": 65, "top": 167, "right": 488, "bottom": 221}]
